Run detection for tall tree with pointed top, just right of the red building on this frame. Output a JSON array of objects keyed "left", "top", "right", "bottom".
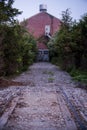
[{"left": 49, "top": 9, "right": 73, "bottom": 68}]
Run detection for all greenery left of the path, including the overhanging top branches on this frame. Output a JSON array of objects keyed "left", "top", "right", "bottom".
[{"left": 0, "top": 0, "right": 36, "bottom": 76}]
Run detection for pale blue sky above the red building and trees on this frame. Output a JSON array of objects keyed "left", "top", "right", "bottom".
[{"left": 13, "top": 0, "right": 87, "bottom": 21}]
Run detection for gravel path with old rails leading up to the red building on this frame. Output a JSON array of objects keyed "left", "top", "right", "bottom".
[{"left": 0, "top": 63, "right": 87, "bottom": 130}]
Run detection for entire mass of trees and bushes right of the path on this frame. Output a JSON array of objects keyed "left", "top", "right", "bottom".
[{"left": 48, "top": 9, "right": 87, "bottom": 82}]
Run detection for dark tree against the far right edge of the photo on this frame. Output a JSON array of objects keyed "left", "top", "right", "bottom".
[{"left": 72, "top": 14, "right": 87, "bottom": 68}]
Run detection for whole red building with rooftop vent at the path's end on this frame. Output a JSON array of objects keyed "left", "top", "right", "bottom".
[{"left": 22, "top": 4, "right": 61, "bottom": 61}]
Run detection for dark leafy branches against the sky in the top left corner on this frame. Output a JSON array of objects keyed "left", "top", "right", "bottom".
[{"left": 0, "top": 0, "right": 22, "bottom": 24}]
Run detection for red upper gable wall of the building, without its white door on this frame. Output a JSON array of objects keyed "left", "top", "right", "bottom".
[{"left": 26, "top": 12, "right": 61, "bottom": 38}]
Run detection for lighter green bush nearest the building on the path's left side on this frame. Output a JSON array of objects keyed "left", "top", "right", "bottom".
[{"left": 21, "top": 32, "right": 37, "bottom": 70}]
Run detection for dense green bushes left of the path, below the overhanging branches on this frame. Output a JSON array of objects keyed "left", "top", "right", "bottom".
[{"left": 0, "top": 24, "right": 36, "bottom": 75}]
